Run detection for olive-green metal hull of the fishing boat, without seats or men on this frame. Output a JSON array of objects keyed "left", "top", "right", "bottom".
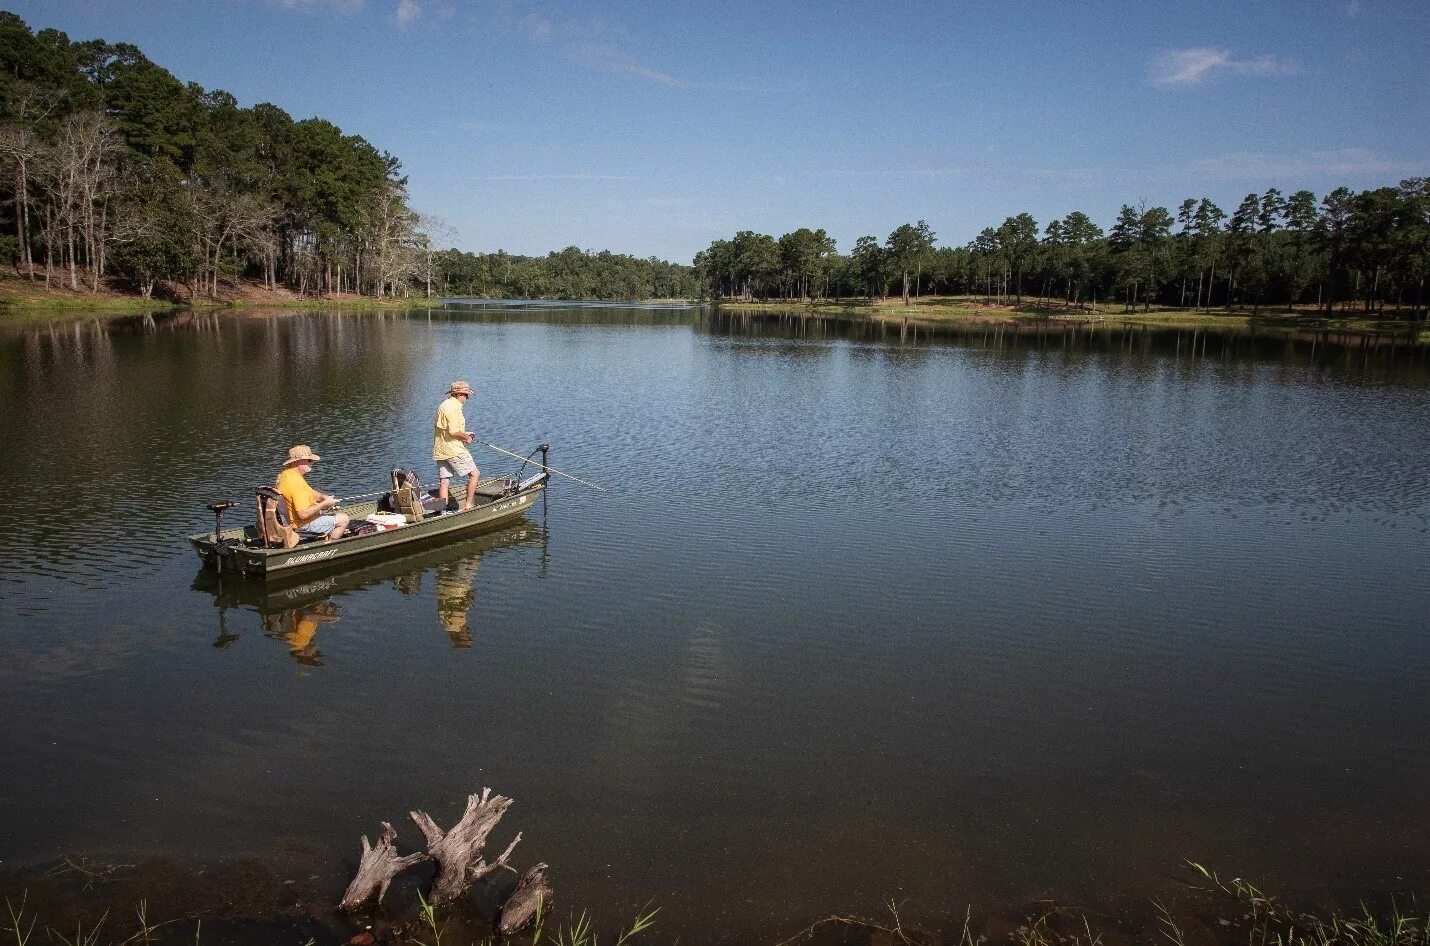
[{"left": 189, "top": 477, "right": 546, "bottom": 580}]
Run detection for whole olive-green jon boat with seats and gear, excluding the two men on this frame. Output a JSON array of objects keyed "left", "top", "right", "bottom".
[{"left": 189, "top": 444, "right": 551, "bottom": 580}]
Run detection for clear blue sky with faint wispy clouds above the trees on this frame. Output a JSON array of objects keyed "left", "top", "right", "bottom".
[{"left": 0, "top": 0, "right": 1430, "bottom": 263}]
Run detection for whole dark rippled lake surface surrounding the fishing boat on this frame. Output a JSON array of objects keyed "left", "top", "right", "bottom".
[{"left": 0, "top": 310, "right": 1430, "bottom": 942}]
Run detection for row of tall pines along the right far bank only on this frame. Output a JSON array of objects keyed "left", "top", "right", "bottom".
[{"left": 695, "top": 177, "right": 1430, "bottom": 317}]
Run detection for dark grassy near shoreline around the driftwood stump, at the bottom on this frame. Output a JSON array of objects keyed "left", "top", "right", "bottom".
[{"left": 0, "top": 856, "right": 1430, "bottom": 946}]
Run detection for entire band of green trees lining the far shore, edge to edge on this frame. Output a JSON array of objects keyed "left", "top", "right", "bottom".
[{"left": 0, "top": 11, "right": 1430, "bottom": 312}]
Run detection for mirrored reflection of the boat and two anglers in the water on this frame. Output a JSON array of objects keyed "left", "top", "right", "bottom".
[{"left": 193, "top": 522, "right": 546, "bottom": 667}]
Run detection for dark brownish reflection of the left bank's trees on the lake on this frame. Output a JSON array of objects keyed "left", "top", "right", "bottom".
[{"left": 0, "top": 313, "right": 429, "bottom": 579}]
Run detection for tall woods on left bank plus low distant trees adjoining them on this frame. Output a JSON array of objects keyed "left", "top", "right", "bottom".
[{"left": 0, "top": 11, "right": 698, "bottom": 300}]
